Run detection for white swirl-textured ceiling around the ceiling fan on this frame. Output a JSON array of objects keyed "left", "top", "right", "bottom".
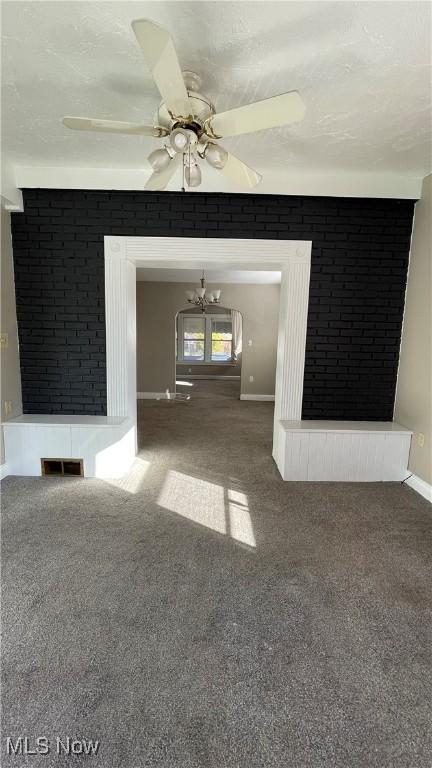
[{"left": 2, "top": 1, "right": 431, "bottom": 202}]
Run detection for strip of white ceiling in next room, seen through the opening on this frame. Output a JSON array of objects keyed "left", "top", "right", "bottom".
[{"left": 136, "top": 267, "right": 281, "bottom": 286}]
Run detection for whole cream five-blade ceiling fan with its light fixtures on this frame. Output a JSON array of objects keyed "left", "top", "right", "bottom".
[{"left": 63, "top": 19, "right": 305, "bottom": 191}]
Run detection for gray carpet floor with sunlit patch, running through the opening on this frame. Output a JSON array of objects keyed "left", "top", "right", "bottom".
[{"left": 2, "top": 382, "right": 432, "bottom": 768}]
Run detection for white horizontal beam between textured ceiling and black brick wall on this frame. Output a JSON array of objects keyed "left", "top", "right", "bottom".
[{"left": 13, "top": 165, "right": 422, "bottom": 200}]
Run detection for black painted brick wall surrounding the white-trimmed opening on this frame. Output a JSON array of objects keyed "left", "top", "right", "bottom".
[{"left": 12, "top": 189, "right": 414, "bottom": 420}]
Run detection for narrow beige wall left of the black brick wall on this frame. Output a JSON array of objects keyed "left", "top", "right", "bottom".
[{"left": 0, "top": 208, "right": 22, "bottom": 464}]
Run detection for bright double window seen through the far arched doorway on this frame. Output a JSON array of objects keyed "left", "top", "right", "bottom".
[{"left": 177, "top": 313, "right": 232, "bottom": 363}]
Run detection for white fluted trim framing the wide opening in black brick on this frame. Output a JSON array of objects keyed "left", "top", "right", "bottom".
[{"left": 104, "top": 231, "right": 312, "bottom": 476}]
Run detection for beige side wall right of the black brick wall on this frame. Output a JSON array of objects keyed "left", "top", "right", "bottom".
[{"left": 395, "top": 175, "right": 432, "bottom": 483}]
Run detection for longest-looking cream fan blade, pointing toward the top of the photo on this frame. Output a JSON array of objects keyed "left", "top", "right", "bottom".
[{"left": 132, "top": 19, "right": 192, "bottom": 118}]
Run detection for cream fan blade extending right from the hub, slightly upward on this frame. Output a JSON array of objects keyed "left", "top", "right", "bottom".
[{"left": 205, "top": 91, "right": 306, "bottom": 139}]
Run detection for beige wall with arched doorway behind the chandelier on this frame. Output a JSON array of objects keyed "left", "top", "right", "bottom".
[{"left": 137, "top": 282, "right": 280, "bottom": 395}]
